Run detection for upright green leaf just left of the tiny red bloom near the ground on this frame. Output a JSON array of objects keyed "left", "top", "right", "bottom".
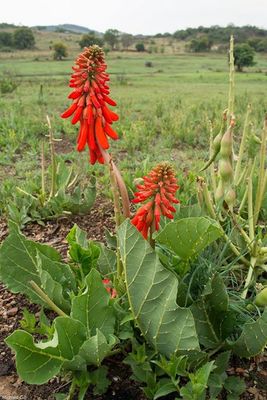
[{"left": 71, "top": 268, "right": 115, "bottom": 338}]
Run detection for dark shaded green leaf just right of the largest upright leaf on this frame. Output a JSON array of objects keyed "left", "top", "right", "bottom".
[{"left": 190, "top": 274, "right": 232, "bottom": 348}]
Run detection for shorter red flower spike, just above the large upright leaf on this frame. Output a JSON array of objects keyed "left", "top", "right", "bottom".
[{"left": 132, "top": 162, "right": 179, "bottom": 239}]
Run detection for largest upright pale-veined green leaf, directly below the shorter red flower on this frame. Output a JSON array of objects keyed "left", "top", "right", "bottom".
[{"left": 118, "top": 220, "right": 199, "bottom": 357}]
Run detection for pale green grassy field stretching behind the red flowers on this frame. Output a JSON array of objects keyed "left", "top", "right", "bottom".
[{"left": 0, "top": 44, "right": 267, "bottom": 216}]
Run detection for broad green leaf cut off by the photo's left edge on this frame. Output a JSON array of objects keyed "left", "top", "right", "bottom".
[{"left": 0, "top": 222, "right": 61, "bottom": 303}]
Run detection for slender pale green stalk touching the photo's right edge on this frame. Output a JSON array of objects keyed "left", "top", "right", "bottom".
[{"left": 254, "top": 115, "right": 267, "bottom": 226}]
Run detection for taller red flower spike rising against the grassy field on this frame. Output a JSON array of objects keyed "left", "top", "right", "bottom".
[{"left": 61, "top": 45, "right": 119, "bottom": 164}]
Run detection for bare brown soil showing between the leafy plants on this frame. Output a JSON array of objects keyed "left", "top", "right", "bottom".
[{"left": 0, "top": 198, "right": 267, "bottom": 400}]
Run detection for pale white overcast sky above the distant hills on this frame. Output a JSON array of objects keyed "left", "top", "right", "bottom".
[{"left": 0, "top": 0, "right": 267, "bottom": 34}]
